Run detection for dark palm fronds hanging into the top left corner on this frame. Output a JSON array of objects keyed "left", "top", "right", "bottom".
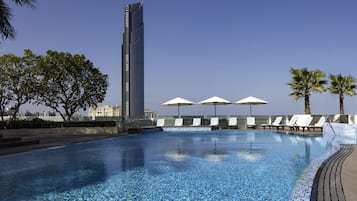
[{"left": 0, "top": 0, "right": 36, "bottom": 39}]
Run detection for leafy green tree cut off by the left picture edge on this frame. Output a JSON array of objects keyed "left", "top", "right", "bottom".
[{"left": 0, "top": 50, "right": 38, "bottom": 120}]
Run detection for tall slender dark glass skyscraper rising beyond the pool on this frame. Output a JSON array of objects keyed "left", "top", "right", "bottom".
[{"left": 122, "top": 3, "right": 144, "bottom": 118}]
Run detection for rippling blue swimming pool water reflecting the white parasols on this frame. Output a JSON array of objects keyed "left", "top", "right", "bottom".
[{"left": 0, "top": 130, "right": 327, "bottom": 200}]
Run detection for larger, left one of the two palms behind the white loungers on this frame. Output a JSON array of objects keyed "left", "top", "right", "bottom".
[{"left": 288, "top": 67, "right": 327, "bottom": 114}]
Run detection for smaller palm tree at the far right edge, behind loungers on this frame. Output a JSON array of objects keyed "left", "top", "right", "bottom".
[{"left": 328, "top": 74, "right": 356, "bottom": 114}]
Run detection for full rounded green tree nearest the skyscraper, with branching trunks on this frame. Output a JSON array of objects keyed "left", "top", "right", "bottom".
[{"left": 36, "top": 50, "right": 108, "bottom": 121}]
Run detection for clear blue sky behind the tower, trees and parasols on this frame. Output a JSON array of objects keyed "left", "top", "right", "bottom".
[{"left": 0, "top": 0, "right": 357, "bottom": 115}]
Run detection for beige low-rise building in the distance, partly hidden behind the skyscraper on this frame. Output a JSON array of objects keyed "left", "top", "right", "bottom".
[{"left": 88, "top": 105, "right": 157, "bottom": 120}]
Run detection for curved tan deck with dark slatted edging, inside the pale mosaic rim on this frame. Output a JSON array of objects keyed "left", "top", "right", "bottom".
[{"left": 311, "top": 145, "right": 357, "bottom": 201}]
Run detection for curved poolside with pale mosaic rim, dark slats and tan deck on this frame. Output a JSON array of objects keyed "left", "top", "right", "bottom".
[{"left": 289, "top": 144, "right": 357, "bottom": 201}]
